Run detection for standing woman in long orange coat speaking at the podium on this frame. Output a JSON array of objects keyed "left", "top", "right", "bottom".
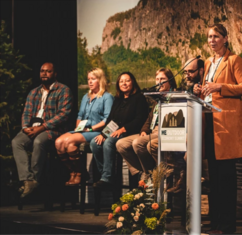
[{"left": 194, "top": 24, "right": 242, "bottom": 235}]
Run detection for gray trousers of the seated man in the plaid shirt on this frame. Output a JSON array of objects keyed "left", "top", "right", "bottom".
[{"left": 12, "top": 131, "right": 53, "bottom": 181}]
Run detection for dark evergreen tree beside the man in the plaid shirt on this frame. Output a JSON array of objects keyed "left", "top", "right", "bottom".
[{"left": 0, "top": 21, "right": 31, "bottom": 158}]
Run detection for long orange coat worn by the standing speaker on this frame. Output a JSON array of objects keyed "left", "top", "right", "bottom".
[{"left": 203, "top": 49, "right": 242, "bottom": 160}]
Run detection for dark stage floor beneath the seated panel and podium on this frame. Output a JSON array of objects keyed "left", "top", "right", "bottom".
[{"left": 0, "top": 205, "right": 242, "bottom": 235}]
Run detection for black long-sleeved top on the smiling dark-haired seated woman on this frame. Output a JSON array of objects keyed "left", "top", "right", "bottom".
[{"left": 106, "top": 92, "right": 149, "bottom": 135}]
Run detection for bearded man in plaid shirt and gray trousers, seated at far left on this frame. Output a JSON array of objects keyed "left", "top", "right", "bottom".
[{"left": 12, "top": 62, "right": 72, "bottom": 197}]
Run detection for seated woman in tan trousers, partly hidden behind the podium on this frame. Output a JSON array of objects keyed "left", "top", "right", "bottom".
[{"left": 116, "top": 68, "right": 176, "bottom": 184}]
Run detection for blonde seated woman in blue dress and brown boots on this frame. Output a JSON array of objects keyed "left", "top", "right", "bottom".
[{"left": 55, "top": 68, "right": 113, "bottom": 185}]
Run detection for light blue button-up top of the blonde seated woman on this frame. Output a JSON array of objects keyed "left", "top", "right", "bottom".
[{"left": 77, "top": 92, "right": 113, "bottom": 127}]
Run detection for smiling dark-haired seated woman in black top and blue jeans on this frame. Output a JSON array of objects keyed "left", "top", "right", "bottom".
[{"left": 90, "top": 72, "right": 148, "bottom": 188}]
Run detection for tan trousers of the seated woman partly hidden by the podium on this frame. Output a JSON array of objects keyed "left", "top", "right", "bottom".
[{"left": 116, "top": 127, "right": 158, "bottom": 175}]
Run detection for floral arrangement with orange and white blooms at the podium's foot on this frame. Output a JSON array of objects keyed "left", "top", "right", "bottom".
[{"left": 106, "top": 162, "right": 170, "bottom": 235}]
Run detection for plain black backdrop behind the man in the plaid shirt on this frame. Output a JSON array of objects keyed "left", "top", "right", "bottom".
[{"left": 1, "top": 0, "right": 77, "bottom": 123}]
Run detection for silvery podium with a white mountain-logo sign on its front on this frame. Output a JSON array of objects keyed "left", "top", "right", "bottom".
[{"left": 144, "top": 91, "right": 221, "bottom": 235}]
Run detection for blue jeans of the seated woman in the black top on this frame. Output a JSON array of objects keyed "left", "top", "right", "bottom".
[{"left": 90, "top": 135, "right": 124, "bottom": 183}]
